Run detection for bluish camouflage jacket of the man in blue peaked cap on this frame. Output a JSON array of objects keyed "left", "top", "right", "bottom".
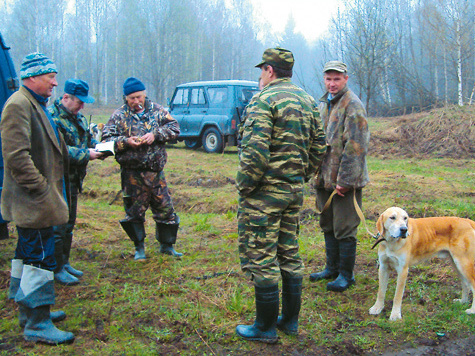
[{"left": 48, "top": 98, "right": 97, "bottom": 191}]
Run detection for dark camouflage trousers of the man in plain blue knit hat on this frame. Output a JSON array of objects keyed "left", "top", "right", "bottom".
[{"left": 121, "top": 168, "right": 177, "bottom": 224}]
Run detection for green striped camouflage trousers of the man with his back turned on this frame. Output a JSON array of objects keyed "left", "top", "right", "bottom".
[{"left": 238, "top": 191, "right": 304, "bottom": 286}]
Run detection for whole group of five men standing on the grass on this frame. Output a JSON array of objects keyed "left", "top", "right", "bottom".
[{"left": 0, "top": 48, "right": 369, "bottom": 344}]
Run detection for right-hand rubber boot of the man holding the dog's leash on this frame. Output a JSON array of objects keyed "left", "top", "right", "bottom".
[{"left": 327, "top": 237, "right": 356, "bottom": 292}]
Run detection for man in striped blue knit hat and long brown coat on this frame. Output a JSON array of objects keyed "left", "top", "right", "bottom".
[{"left": 0, "top": 53, "right": 74, "bottom": 344}]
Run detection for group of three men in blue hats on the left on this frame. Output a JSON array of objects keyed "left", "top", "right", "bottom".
[{"left": 0, "top": 52, "right": 182, "bottom": 344}]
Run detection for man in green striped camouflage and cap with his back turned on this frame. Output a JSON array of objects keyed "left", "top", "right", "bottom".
[{"left": 236, "top": 48, "right": 326, "bottom": 343}]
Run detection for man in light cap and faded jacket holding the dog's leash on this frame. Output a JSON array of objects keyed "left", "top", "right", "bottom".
[{"left": 310, "top": 61, "right": 369, "bottom": 292}]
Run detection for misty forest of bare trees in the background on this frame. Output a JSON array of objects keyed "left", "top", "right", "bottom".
[{"left": 0, "top": 0, "right": 475, "bottom": 115}]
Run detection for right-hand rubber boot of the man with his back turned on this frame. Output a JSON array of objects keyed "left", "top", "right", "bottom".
[{"left": 277, "top": 277, "right": 302, "bottom": 335}]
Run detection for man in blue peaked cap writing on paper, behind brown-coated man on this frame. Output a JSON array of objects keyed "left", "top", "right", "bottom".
[{"left": 48, "top": 79, "right": 102, "bottom": 285}]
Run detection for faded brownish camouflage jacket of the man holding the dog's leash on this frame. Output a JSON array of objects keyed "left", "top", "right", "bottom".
[{"left": 315, "top": 87, "right": 369, "bottom": 190}]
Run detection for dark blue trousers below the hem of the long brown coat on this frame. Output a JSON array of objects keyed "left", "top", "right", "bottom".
[{"left": 15, "top": 226, "right": 56, "bottom": 271}]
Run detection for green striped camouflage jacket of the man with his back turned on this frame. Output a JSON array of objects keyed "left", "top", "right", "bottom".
[{"left": 236, "top": 78, "right": 326, "bottom": 196}]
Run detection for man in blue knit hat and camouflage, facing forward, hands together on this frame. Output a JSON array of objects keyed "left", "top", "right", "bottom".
[{"left": 102, "top": 77, "right": 182, "bottom": 260}]
